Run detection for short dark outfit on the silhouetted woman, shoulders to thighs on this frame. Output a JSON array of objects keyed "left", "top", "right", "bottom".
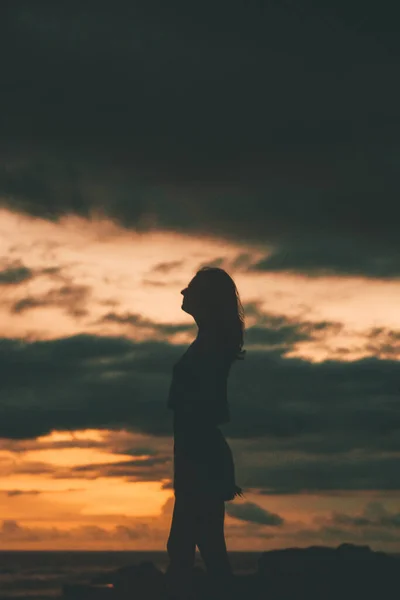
[{"left": 167, "top": 335, "right": 242, "bottom": 501}]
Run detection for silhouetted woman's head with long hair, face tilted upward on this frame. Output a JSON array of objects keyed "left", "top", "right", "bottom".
[{"left": 181, "top": 267, "right": 244, "bottom": 358}]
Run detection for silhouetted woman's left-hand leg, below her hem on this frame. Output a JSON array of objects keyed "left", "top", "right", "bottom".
[{"left": 166, "top": 494, "right": 196, "bottom": 598}]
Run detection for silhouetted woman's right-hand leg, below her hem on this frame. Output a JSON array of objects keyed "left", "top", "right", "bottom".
[{"left": 196, "top": 497, "right": 233, "bottom": 598}]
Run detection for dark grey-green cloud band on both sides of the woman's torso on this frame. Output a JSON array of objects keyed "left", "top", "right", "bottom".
[{"left": 0, "top": 335, "right": 399, "bottom": 444}]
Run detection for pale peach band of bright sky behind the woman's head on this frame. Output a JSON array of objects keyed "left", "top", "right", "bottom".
[{"left": 0, "top": 209, "right": 400, "bottom": 360}]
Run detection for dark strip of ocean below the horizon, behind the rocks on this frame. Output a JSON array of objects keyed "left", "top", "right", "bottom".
[{"left": 0, "top": 550, "right": 261, "bottom": 600}]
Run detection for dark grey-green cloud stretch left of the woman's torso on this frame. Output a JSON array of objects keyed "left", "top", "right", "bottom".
[{"left": 0, "top": 335, "right": 180, "bottom": 439}]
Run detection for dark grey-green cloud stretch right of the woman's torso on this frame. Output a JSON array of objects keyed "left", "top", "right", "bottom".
[{"left": 229, "top": 351, "right": 400, "bottom": 441}]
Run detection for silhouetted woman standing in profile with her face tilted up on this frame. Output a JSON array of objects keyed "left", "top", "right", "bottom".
[{"left": 167, "top": 267, "right": 245, "bottom": 599}]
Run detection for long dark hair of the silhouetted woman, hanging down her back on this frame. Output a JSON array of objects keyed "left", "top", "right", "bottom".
[{"left": 195, "top": 267, "right": 246, "bottom": 360}]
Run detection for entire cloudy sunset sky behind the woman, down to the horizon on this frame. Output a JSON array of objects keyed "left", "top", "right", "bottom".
[{"left": 0, "top": 0, "right": 400, "bottom": 552}]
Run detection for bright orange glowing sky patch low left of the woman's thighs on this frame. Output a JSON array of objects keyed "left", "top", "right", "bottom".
[{"left": 0, "top": 429, "right": 171, "bottom": 523}]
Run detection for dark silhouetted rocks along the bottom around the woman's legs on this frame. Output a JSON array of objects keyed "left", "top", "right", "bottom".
[{"left": 63, "top": 544, "right": 400, "bottom": 600}]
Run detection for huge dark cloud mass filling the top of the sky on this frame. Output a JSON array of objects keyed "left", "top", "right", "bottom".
[{"left": 0, "top": 0, "right": 400, "bottom": 277}]
